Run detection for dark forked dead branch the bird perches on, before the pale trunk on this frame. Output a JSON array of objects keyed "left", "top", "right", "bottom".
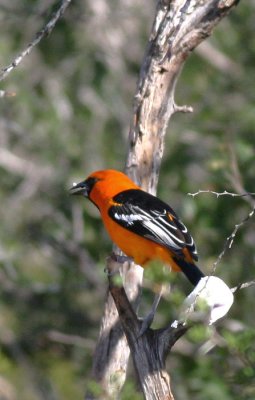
[{"left": 105, "top": 257, "right": 189, "bottom": 400}]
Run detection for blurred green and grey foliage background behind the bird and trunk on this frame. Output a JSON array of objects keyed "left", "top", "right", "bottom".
[{"left": 0, "top": 0, "right": 255, "bottom": 400}]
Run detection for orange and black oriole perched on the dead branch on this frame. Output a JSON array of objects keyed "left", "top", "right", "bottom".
[{"left": 71, "top": 170, "right": 204, "bottom": 286}]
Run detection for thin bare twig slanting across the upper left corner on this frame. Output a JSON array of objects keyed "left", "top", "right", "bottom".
[{"left": 0, "top": 0, "right": 72, "bottom": 81}]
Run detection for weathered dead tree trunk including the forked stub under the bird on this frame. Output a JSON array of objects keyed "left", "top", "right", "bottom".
[{"left": 87, "top": 0, "right": 239, "bottom": 399}]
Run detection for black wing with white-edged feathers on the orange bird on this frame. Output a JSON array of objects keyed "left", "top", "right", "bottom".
[{"left": 109, "top": 189, "right": 198, "bottom": 260}]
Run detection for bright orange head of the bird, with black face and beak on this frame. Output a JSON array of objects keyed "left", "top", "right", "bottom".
[{"left": 70, "top": 169, "right": 140, "bottom": 208}]
